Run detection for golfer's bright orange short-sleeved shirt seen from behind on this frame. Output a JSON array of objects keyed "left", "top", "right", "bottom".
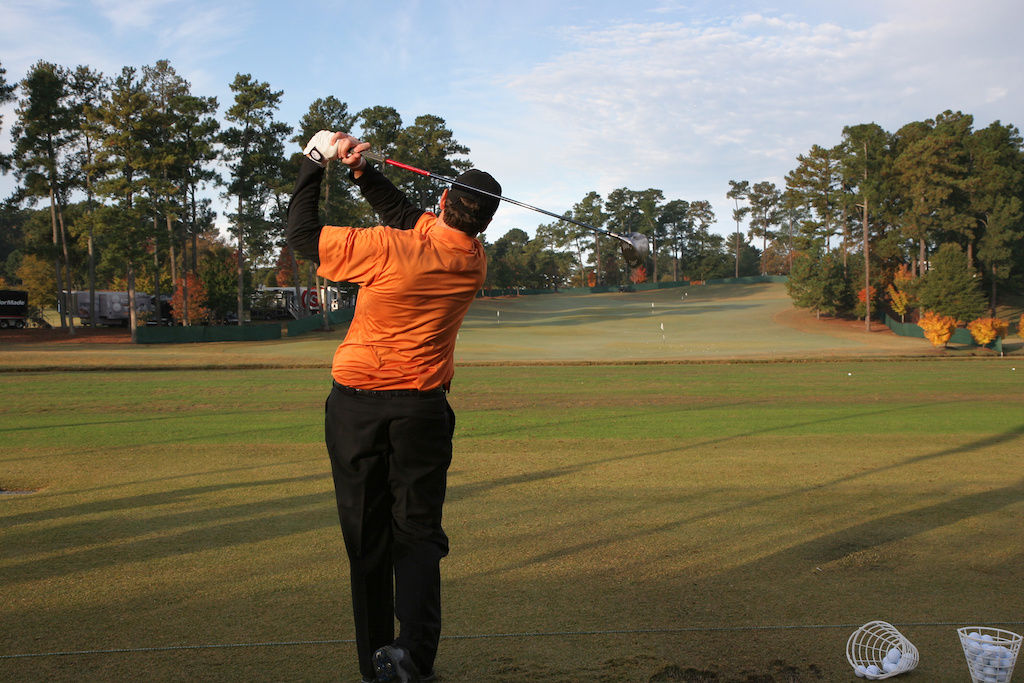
[{"left": 316, "top": 213, "right": 486, "bottom": 391}]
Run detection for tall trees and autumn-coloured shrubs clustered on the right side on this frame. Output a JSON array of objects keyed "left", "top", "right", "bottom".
[{"left": 729, "top": 111, "right": 1024, "bottom": 333}]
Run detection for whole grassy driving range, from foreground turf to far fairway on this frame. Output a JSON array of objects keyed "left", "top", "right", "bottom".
[{"left": 0, "top": 288, "right": 1024, "bottom": 682}]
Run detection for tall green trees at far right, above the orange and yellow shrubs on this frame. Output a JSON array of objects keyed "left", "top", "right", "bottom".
[{"left": 782, "top": 111, "right": 1024, "bottom": 327}]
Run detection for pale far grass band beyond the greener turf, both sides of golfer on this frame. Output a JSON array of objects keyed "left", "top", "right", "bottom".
[{"left": 8, "top": 284, "right": 978, "bottom": 370}]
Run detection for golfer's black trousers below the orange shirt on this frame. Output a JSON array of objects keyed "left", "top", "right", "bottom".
[{"left": 325, "top": 385, "right": 455, "bottom": 679}]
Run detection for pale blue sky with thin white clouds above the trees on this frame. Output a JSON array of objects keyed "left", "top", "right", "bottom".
[{"left": 0, "top": 0, "right": 1024, "bottom": 240}]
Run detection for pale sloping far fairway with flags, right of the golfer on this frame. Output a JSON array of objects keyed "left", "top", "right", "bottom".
[{"left": 460, "top": 284, "right": 929, "bottom": 361}]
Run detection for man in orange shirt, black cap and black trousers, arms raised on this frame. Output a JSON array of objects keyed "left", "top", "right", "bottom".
[{"left": 287, "top": 131, "right": 501, "bottom": 682}]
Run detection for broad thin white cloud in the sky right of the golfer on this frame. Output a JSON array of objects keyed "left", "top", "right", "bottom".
[{"left": 489, "top": 2, "right": 1024, "bottom": 235}]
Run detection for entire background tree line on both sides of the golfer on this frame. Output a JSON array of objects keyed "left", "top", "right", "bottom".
[{"left": 0, "top": 60, "right": 1024, "bottom": 337}]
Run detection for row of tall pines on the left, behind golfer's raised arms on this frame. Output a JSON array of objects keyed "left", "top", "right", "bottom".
[{"left": 0, "top": 60, "right": 483, "bottom": 331}]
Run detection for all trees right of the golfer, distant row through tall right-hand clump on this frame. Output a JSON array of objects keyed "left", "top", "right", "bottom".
[{"left": 495, "top": 111, "right": 1024, "bottom": 344}]
